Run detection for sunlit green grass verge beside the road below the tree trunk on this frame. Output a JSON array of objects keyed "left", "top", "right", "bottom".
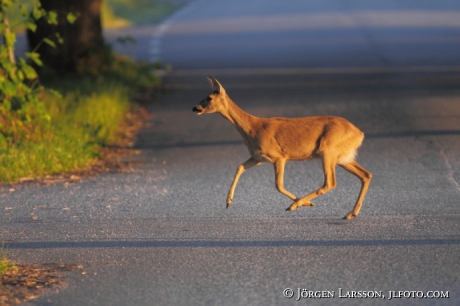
[{"left": 0, "top": 57, "right": 160, "bottom": 182}]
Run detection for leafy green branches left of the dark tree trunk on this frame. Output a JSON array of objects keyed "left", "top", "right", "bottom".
[{"left": 0, "top": 0, "right": 61, "bottom": 147}]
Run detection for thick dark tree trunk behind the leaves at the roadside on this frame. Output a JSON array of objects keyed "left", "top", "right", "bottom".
[{"left": 27, "top": 0, "right": 110, "bottom": 75}]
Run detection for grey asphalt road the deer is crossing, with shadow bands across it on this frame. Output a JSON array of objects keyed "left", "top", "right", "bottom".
[{"left": 0, "top": 0, "right": 460, "bottom": 305}]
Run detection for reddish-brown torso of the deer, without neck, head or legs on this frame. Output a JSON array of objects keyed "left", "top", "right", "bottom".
[{"left": 247, "top": 116, "right": 364, "bottom": 161}]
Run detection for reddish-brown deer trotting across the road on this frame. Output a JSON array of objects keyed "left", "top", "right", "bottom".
[{"left": 192, "top": 76, "right": 372, "bottom": 220}]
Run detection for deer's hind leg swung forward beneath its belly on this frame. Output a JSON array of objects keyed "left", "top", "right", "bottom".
[{"left": 286, "top": 155, "right": 337, "bottom": 211}]
